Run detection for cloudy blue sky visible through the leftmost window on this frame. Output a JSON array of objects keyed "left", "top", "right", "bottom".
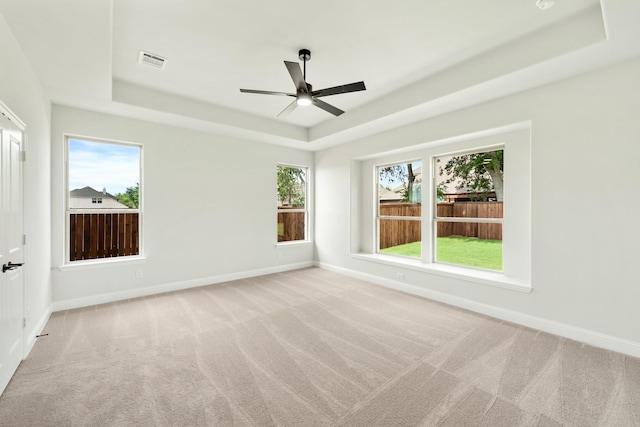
[{"left": 69, "top": 139, "right": 140, "bottom": 196}]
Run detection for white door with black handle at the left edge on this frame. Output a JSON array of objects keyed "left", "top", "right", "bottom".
[{"left": 0, "top": 108, "right": 24, "bottom": 393}]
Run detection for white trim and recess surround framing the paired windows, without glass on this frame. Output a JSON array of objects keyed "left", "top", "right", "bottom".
[{"left": 351, "top": 123, "right": 532, "bottom": 292}]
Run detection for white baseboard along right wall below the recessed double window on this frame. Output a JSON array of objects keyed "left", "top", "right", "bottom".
[{"left": 315, "top": 262, "right": 640, "bottom": 358}]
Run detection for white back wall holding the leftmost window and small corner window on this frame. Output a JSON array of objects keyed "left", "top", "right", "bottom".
[{"left": 51, "top": 105, "right": 313, "bottom": 309}]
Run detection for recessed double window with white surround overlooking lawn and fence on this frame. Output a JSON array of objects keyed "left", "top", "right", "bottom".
[{"left": 358, "top": 128, "right": 531, "bottom": 292}]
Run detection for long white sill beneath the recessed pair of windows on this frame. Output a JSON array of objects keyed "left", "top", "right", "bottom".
[{"left": 351, "top": 253, "right": 533, "bottom": 293}]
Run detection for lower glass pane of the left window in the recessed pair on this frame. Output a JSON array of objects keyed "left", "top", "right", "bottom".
[{"left": 378, "top": 219, "right": 422, "bottom": 258}]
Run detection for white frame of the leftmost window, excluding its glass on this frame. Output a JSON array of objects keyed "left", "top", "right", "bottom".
[{"left": 62, "top": 134, "right": 146, "bottom": 268}]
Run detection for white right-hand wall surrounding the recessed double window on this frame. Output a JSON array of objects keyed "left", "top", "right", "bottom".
[{"left": 315, "top": 60, "right": 640, "bottom": 356}]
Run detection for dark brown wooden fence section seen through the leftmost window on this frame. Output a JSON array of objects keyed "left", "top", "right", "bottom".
[{"left": 69, "top": 212, "right": 140, "bottom": 261}]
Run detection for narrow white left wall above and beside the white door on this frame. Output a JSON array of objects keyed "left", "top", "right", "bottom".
[{"left": 0, "top": 15, "right": 51, "bottom": 347}]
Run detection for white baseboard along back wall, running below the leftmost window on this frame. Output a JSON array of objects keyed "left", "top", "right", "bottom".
[{"left": 52, "top": 261, "right": 315, "bottom": 312}]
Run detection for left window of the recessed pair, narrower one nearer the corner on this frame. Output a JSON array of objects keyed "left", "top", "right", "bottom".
[{"left": 376, "top": 161, "right": 422, "bottom": 258}]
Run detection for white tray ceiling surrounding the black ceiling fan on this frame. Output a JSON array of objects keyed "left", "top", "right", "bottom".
[{"left": 0, "top": 0, "right": 640, "bottom": 150}]
